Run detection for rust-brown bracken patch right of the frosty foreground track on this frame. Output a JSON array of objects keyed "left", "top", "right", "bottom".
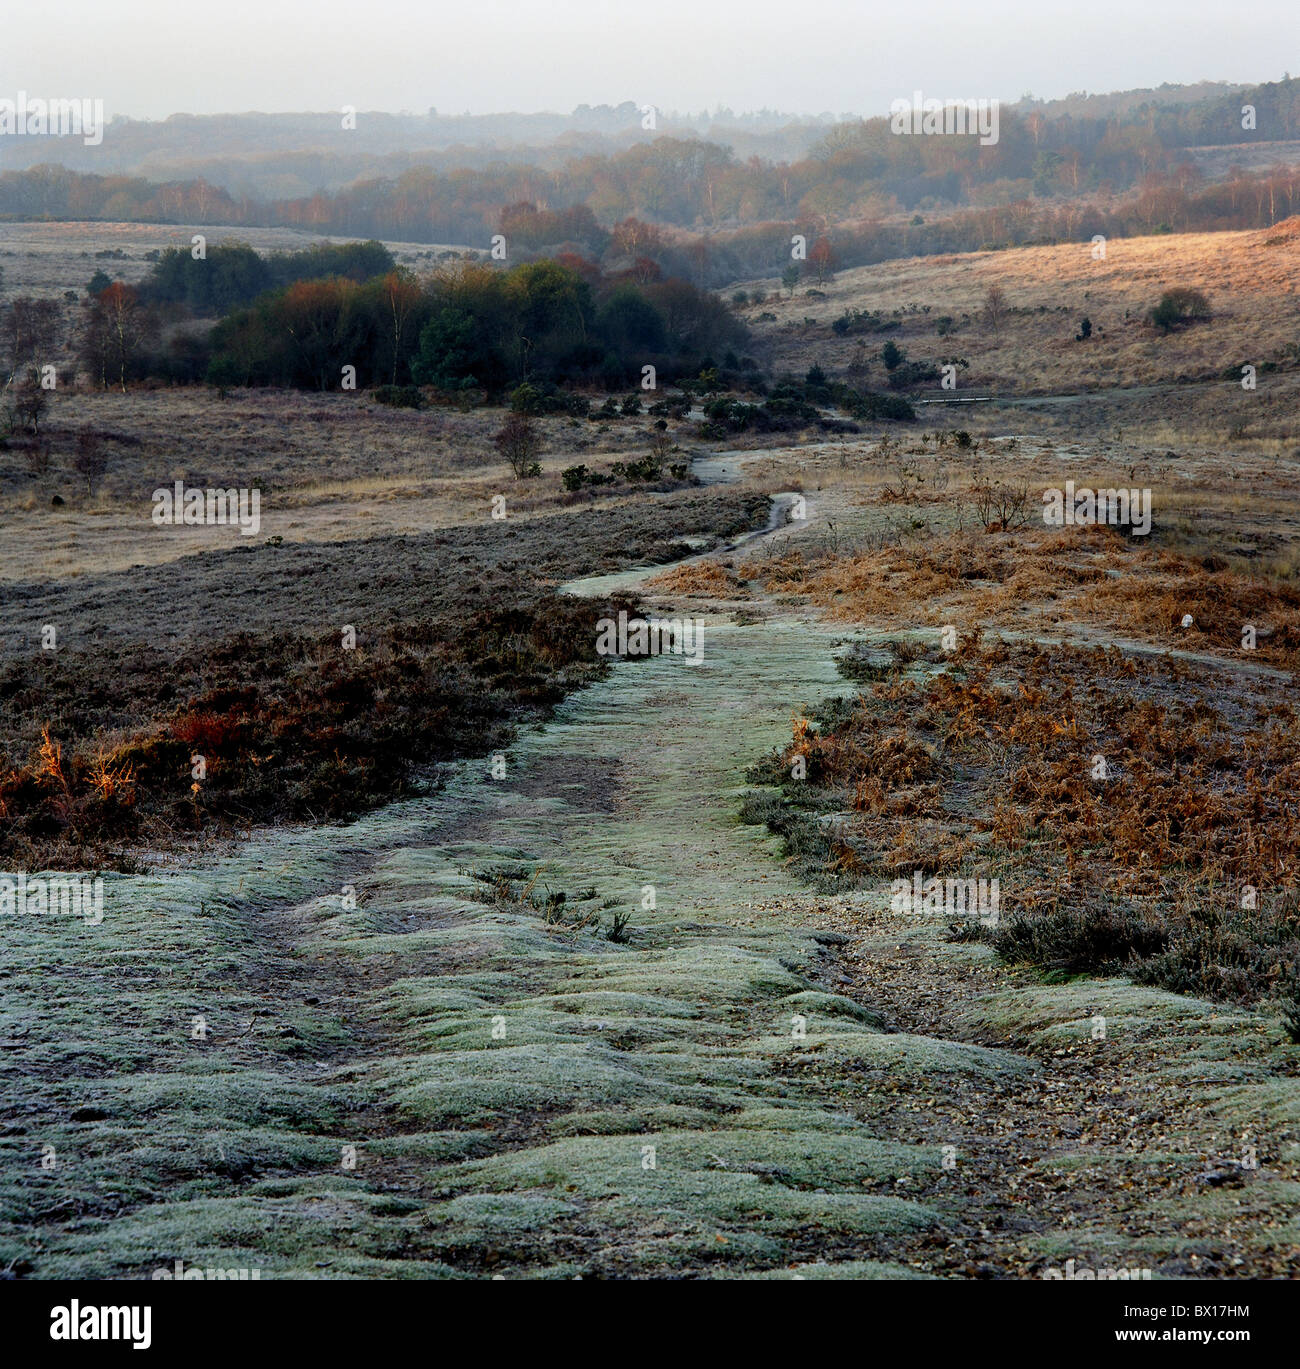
[{"left": 751, "top": 639, "right": 1300, "bottom": 1002}]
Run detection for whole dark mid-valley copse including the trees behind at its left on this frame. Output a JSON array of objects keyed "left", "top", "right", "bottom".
[{"left": 45, "top": 242, "right": 753, "bottom": 396}]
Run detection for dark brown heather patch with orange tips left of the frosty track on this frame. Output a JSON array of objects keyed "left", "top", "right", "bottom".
[{"left": 0, "top": 596, "right": 628, "bottom": 868}]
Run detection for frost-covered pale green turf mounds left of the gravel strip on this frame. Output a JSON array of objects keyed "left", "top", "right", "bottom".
[{"left": 0, "top": 616, "right": 1015, "bottom": 1277}]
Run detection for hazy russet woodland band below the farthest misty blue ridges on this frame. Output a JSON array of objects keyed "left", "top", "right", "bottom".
[{"left": 0, "top": 79, "right": 1300, "bottom": 256}]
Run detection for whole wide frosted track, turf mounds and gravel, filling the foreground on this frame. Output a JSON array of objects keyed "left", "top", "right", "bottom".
[{"left": 0, "top": 465, "right": 1300, "bottom": 1277}]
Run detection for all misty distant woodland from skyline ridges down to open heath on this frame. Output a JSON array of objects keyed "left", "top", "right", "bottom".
[{"left": 0, "top": 79, "right": 1300, "bottom": 286}]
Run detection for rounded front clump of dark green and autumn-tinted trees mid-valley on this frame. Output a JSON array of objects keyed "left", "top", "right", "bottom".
[{"left": 207, "top": 259, "right": 749, "bottom": 394}]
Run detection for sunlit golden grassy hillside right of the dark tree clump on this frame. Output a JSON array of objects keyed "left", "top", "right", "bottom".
[{"left": 742, "top": 218, "right": 1300, "bottom": 394}]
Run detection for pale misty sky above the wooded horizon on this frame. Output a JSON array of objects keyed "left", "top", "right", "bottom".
[{"left": 0, "top": 0, "right": 1300, "bottom": 118}]
